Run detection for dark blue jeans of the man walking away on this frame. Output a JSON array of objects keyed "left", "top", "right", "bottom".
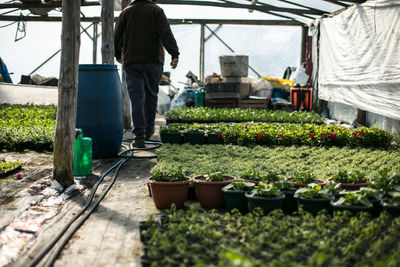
[{"left": 124, "top": 63, "right": 163, "bottom": 136}]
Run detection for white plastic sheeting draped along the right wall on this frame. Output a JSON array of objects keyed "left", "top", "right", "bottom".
[{"left": 318, "top": 0, "right": 400, "bottom": 120}]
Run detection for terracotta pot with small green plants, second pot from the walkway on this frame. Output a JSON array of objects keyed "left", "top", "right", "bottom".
[{"left": 192, "top": 172, "right": 236, "bottom": 209}]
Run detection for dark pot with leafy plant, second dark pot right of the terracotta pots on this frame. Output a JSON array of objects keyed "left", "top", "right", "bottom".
[{"left": 245, "top": 182, "right": 285, "bottom": 214}]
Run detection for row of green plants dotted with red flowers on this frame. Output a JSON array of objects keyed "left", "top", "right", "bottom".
[{"left": 161, "top": 122, "right": 392, "bottom": 148}]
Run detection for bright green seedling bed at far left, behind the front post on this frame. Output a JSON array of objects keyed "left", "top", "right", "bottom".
[{"left": 0, "top": 104, "right": 57, "bottom": 151}]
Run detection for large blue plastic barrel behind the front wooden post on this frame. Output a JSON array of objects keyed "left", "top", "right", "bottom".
[{"left": 76, "top": 64, "right": 123, "bottom": 159}]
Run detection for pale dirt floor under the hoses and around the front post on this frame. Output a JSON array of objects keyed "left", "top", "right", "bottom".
[{"left": 0, "top": 117, "right": 165, "bottom": 266}]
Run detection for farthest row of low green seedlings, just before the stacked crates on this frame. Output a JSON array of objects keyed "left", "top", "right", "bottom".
[{"left": 165, "top": 107, "right": 324, "bottom": 124}]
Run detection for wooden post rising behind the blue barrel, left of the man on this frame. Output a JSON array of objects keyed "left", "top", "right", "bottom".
[{"left": 101, "top": 0, "right": 114, "bottom": 64}]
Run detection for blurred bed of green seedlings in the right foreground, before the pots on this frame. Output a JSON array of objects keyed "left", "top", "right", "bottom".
[{"left": 141, "top": 207, "right": 400, "bottom": 267}]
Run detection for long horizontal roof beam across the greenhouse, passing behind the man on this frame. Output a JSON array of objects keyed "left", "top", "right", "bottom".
[{"left": 0, "top": 16, "right": 304, "bottom": 26}]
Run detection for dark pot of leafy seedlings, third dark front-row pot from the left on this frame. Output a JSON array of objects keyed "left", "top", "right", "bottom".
[{"left": 294, "top": 183, "right": 334, "bottom": 215}]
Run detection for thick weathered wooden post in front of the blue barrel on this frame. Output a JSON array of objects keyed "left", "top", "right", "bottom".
[{"left": 53, "top": 0, "right": 81, "bottom": 188}]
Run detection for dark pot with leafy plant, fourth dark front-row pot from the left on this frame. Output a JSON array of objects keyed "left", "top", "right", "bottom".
[{"left": 330, "top": 192, "right": 373, "bottom": 217}]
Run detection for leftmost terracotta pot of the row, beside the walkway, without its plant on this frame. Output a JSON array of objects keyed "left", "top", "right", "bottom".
[{"left": 148, "top": 177, "right": 190, "bottom": 209}]
